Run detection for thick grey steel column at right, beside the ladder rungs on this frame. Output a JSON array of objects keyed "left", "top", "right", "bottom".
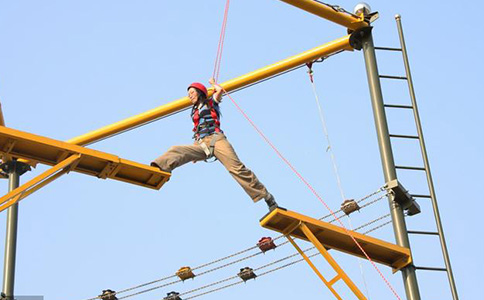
[{"left": 362, "top": 32, "right": 420, "bottom": 300}]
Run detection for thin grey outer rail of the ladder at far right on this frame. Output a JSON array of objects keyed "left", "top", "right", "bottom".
[{"left": 395, "top": 15, "right": 459, "bottom": 300}]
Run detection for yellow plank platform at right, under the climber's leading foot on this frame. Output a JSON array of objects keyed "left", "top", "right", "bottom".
[{"left": 260, "top": 208, "right": 411, "bottom": 271}]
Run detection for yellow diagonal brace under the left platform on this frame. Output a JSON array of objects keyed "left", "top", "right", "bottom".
[{"left": 0, "top": 154, "right": 81, "bottom": 212}]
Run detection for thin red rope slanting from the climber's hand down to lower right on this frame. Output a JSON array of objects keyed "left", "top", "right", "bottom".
[{"left": 223, "top": 89, "right": 401, "bottom": 300}]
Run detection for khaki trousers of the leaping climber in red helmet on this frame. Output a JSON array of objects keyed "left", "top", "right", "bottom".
[{"left": 152, "top": 133, "right": 268, "bottom": 202}]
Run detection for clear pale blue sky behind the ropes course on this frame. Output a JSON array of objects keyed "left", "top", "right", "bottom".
[{"left": 0, "top": 0, "right": 484, "bottom": 300}]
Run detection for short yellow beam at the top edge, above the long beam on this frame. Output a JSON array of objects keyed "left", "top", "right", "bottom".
[{"left": 281, "top": 0, "right": 369, "bottom": 30}]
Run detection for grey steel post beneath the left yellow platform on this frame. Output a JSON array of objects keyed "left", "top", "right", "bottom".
[{"left": 3, "top": 161, "right": 20, "bottom": 300}]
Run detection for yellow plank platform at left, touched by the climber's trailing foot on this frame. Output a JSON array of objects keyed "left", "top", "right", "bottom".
[{"left": 0, "top": 126, "right": 171, "bottom": 189}]
